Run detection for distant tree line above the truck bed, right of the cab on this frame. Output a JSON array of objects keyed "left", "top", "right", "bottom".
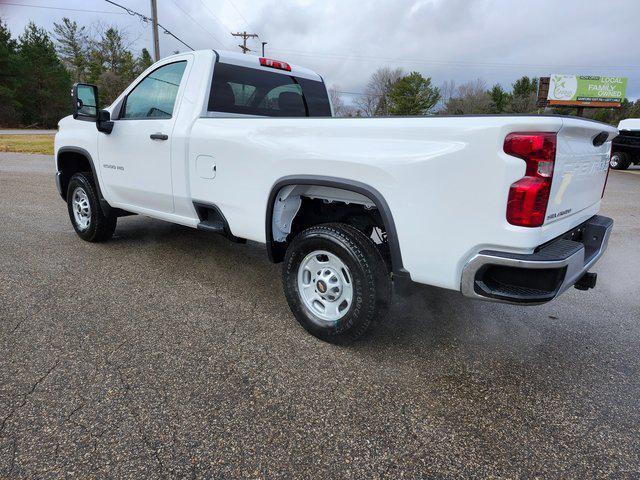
[{"left": 330, "top": 67, "right": 640, "bottom": 125}]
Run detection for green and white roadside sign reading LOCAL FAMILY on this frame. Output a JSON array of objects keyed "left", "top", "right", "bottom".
[{"left": 547, "top": 75, "right": 627, "bottom": 107}]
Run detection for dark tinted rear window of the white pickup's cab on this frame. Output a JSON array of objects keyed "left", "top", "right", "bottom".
[{"left": 207, "top": 63, "right": 331, "bottom": 117}]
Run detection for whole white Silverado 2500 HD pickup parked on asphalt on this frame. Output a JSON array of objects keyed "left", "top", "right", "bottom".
[{"left": 55, "top": 50, "right": 618, "bottom": 342}]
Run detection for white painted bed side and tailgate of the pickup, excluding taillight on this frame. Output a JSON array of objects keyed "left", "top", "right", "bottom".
[{"left": 188, "top": 116, "right": 617, "bottom": 289}]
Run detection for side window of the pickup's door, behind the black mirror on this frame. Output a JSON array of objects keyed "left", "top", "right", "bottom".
[{"left": 120, "top": 61, "right": 187, "bottom": 118}]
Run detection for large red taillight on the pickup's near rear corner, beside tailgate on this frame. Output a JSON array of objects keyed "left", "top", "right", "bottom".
[{"left": 504, "top": 132, "right": 557, "bottom": 227}]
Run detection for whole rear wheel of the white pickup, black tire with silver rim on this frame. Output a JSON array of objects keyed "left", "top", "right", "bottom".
[{"left": 283, "top": 223, "right": 391, "bottom": 344}]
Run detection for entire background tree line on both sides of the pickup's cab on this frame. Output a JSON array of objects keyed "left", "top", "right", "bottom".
[{"left": 0, "top": 18, "right": 640, "bottom": 128}]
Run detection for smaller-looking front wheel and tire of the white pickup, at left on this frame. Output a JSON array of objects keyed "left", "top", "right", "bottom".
[{"left": 67, "top": 173, "right": 118, "bottom": 242}]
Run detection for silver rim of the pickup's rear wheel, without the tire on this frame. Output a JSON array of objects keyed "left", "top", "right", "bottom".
[{"left": 298, "top": 250, "right": 353, "bottom": 322}]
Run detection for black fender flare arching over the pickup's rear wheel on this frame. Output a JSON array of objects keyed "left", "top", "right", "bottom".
[{"left": 265, "top": 175, "right": 408, "bottom": 276}]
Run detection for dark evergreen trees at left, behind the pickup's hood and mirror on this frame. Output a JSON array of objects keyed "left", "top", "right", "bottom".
[{"left": 0, "top": 18, "right": 153, "bottom": 128}]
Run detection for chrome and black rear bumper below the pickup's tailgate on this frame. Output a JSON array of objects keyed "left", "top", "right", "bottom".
[{"left": 461, "top": 215, "right": 613, "bottom": 305}]
